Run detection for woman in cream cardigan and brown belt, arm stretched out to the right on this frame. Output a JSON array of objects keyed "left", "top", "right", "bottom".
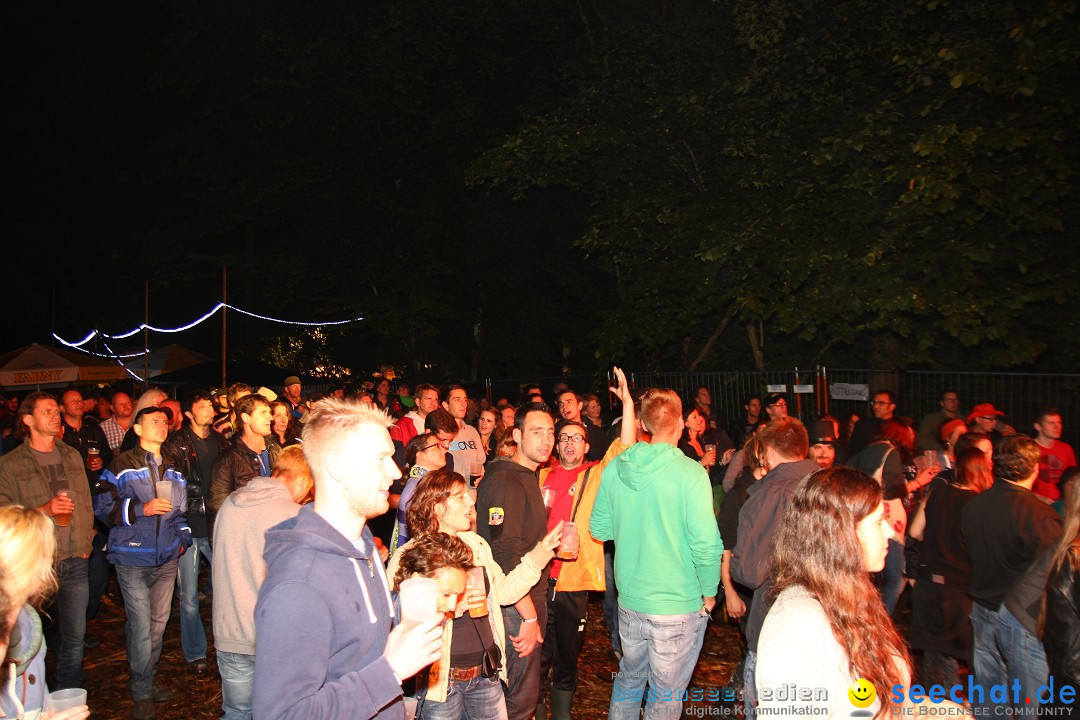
[{"left": 387, "top": 468, "right": 563, "bottom": 720}]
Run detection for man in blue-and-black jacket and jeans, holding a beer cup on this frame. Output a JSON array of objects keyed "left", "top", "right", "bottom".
[{"left": 94, "top": 406, "right": 191, "bottom": 720}]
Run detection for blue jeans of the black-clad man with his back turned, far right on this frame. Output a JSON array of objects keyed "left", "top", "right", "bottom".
[{"left": 968, "top": 602, "right": 1050, "bottom": 716}]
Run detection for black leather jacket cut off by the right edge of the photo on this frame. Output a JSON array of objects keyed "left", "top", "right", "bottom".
[{"left": 1042, "top": 540, "right": 1080, "bottom": 685}]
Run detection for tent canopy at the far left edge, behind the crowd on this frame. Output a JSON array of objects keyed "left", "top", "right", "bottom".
[{"left": 0, "top": 342, "right": 127, "bottom": 388}]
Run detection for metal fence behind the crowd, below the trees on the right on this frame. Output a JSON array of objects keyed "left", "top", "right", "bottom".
[{"left": 486, "top": 366, "right": 1080, "bottom": 447}]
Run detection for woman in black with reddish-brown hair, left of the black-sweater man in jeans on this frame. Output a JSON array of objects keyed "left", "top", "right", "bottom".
[{"left": 908, "top": 446, "right": 994, "bottom": 688}]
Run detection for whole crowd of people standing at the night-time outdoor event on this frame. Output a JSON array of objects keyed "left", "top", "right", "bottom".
[{"left": 0, "top": 377, "right": 1080, "bottom": 720}]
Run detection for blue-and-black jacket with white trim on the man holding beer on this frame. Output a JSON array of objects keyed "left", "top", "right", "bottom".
[{"left": 94, "top": 447, "right": 191, "bottom": 568}]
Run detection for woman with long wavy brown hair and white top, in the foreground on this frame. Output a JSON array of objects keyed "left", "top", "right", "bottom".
[{"left": 756, "top": 467, "right": 933, "bottom": 718}]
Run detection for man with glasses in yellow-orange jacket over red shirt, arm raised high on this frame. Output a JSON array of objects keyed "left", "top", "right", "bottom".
[{"left": 537, "top": 368, "right": 637, "bottom": 720}]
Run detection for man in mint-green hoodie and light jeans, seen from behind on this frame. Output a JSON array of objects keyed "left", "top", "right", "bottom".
[{"left": 590, "top": 389, "right": 724, "bottom": 720}]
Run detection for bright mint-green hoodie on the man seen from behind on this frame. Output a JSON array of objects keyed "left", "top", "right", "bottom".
[{"left": 589, "top": 443, "right": 724, "bottom": 615}]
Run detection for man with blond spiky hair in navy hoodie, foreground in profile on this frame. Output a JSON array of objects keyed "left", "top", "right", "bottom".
[{"left": 253, "top": 398, "right": 443, "bottom": 720}]
